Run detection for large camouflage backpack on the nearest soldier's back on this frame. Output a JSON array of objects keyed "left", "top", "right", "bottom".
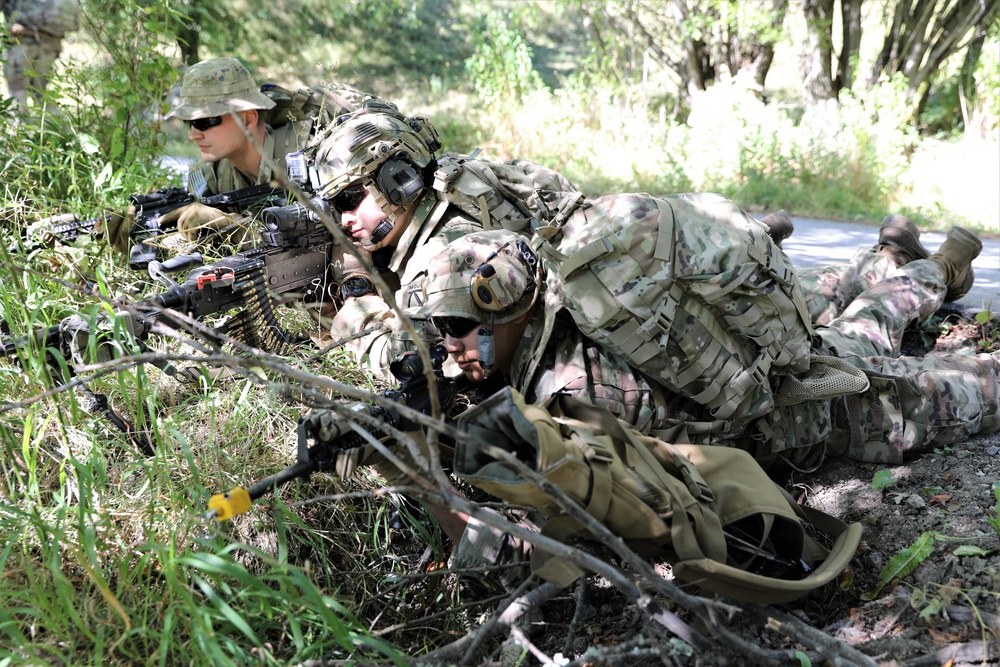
[{"left": 535, "top": 194, "right": 813, "bottom": 432}]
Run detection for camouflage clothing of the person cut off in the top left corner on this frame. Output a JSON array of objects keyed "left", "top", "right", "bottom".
[{"left": 0, "top": 0, "right": 80, "bottom": 109}]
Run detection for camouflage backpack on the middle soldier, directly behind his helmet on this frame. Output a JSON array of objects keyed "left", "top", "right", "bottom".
[{"left": 430, "top": 150, "right": 586, "bottom": 233}]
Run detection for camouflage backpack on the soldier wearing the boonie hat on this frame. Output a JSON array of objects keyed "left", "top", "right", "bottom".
[{"left": 260, "top": 82, "right": 374, "bottom": 128}]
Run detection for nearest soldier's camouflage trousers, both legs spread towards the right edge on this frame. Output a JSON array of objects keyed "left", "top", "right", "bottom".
[{"left": 768, "top": 260, "right": 1000, "bottom": 465}]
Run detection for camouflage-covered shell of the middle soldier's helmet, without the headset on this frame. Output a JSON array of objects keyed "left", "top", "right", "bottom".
[{"left": 315, "top": 102, "right": 441, "bottom": 198}]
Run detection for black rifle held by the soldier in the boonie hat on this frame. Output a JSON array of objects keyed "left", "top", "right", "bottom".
[{"left": 32, "top": 183, "right": 287, "bottom": 271}]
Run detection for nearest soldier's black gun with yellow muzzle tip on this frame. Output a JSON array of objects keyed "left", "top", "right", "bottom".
[{"left": 208, "top": 345, "right": 471, "bottom": 521}]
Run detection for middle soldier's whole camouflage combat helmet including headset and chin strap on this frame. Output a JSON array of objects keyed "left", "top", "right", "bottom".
[{"left": 313, "top": 105, "right": 441, "bottom": 243}]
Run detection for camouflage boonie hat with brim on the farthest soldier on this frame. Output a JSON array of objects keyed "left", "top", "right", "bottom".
[{"left": 167, "top": 58, "right": 274, "bottom": 120}]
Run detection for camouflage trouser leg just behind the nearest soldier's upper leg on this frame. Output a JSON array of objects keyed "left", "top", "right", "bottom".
[{"left": 795, "top": 250, "right": 896, "bottom": 325}]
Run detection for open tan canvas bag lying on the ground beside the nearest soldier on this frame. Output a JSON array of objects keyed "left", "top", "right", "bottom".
[{"left": 455, "top": 387, "right": 861, "bottom": 603}]
